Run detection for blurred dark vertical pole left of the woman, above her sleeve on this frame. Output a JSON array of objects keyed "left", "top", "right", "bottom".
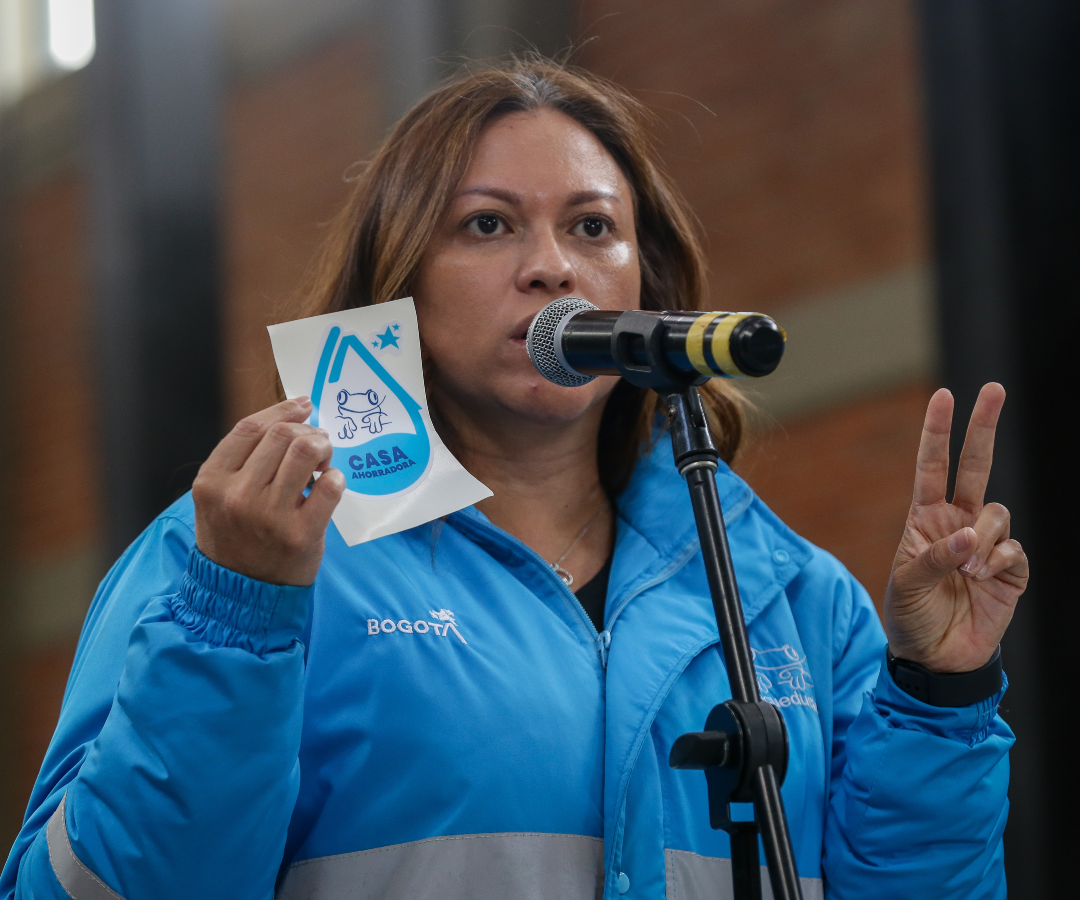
[{"left": 86, "top": 0, "right": 222, "bottom": 556}]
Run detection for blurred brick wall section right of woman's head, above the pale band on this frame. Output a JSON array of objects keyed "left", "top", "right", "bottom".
[{"left": 581, "top": 0, "right": 927, "bottom": 311}]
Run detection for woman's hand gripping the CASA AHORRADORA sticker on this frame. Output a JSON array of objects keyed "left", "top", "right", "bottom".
[{"left": 191, "top": 398, "right": 345, "bottom": 585}]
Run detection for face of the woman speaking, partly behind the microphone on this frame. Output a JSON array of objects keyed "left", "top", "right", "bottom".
[{"left": 416, "top": 110, "right": 640, "bottom": 426}]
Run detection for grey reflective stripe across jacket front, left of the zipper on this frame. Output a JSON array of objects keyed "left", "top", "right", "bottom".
[{"left": 276, "top": 833, "right": 604, "bottom": 900}]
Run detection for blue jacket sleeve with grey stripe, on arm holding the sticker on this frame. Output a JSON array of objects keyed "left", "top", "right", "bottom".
[{"left": 0, "top": 509, "right": 312, "bottom": 900}]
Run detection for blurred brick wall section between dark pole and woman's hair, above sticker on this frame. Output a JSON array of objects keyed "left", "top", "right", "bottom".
[{"left": 224, "top": 33, "right": 382, "bottom": 425}]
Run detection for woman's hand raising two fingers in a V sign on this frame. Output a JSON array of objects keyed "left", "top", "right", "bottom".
[{"left": 885, "top": 384, "right": 1028, "bottom": 672}]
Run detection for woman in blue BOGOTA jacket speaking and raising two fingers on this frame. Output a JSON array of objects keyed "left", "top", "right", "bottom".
[{"left": 0, "top": 57, "right": 1027, "bottom": 900}]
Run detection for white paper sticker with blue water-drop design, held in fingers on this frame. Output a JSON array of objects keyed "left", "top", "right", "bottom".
[{"left": 269, "top": 297, "right": 491, "bottom": 546}]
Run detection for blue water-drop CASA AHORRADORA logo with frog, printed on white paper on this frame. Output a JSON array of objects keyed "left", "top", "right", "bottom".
[{"left": 311, "top": 323, "right": 431, "bottom": 497}]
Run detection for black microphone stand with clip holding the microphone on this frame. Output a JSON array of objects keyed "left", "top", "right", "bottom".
[{"left": 610, "top": 310, "right": 802, "bottom": 900}]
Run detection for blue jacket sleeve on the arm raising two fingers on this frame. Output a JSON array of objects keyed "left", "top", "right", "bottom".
[{"left": 824, "top": 576, "right": 1013, "bottom": 900}]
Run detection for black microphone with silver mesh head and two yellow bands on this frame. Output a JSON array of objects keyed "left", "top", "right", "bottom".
[{"left": 525, "top": 297, "right": 787, "bottom": 390}]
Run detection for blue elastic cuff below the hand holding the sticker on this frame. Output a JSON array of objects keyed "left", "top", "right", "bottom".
[{"left": 175, "top": 547, "right": 314, "bottom": 653}]
